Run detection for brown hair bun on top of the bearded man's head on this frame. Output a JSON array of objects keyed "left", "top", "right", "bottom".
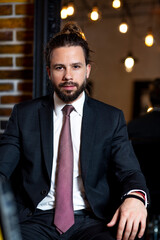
[{"left": 60, "top": 22, "right": 86, "bottom": 40}]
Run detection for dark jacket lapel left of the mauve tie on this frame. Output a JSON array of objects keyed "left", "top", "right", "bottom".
[{"left": 39, "top": 98, "right": 53, "bottom": 179}]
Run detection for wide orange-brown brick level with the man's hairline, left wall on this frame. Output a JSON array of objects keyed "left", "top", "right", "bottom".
[{"left": 0, "top": 44, "right": 33, "bottom": 54}]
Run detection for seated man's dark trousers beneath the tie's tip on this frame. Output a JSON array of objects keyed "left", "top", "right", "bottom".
[{"left": 20, "top": 209, "right": 116, "bottom": 240}]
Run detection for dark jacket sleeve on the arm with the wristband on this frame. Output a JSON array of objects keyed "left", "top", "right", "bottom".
[{"left": 112, "top": 111, "right": 148, "bottom": 197}]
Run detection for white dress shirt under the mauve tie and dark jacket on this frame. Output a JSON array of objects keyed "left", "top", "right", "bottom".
[{"left": 37, "top": 92, "right": 88, "bottom": 210}]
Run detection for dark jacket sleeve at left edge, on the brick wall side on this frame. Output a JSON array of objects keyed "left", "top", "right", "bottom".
[{"left": 0, "top": 106, "right": 20, "bottom": 178}]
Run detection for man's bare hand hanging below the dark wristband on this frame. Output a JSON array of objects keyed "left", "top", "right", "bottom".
[{"left": 107, "top": 198, "right": 147, "bottom": 240}]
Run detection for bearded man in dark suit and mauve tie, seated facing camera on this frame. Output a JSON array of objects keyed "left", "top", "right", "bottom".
[{"left": 0, "top": 23, "right": 148, "bottom": 240}]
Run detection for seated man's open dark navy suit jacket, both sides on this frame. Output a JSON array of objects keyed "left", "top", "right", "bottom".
[{"left": 0, "top": 96, "right": 147, "bottom": 220}]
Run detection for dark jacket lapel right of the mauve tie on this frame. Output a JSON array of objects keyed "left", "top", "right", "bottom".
[{"left": 80, "top": 96, "right": 95, "bottom": 181}]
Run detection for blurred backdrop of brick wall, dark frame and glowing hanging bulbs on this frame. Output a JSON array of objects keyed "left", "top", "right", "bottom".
[{"left": 0, "top": 0, "right": 160, "bottom": 133}]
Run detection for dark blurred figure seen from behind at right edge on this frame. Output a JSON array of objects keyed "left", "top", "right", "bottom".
[{"left": 128, "top": 78, "right": 160, "bottom": 218}]
